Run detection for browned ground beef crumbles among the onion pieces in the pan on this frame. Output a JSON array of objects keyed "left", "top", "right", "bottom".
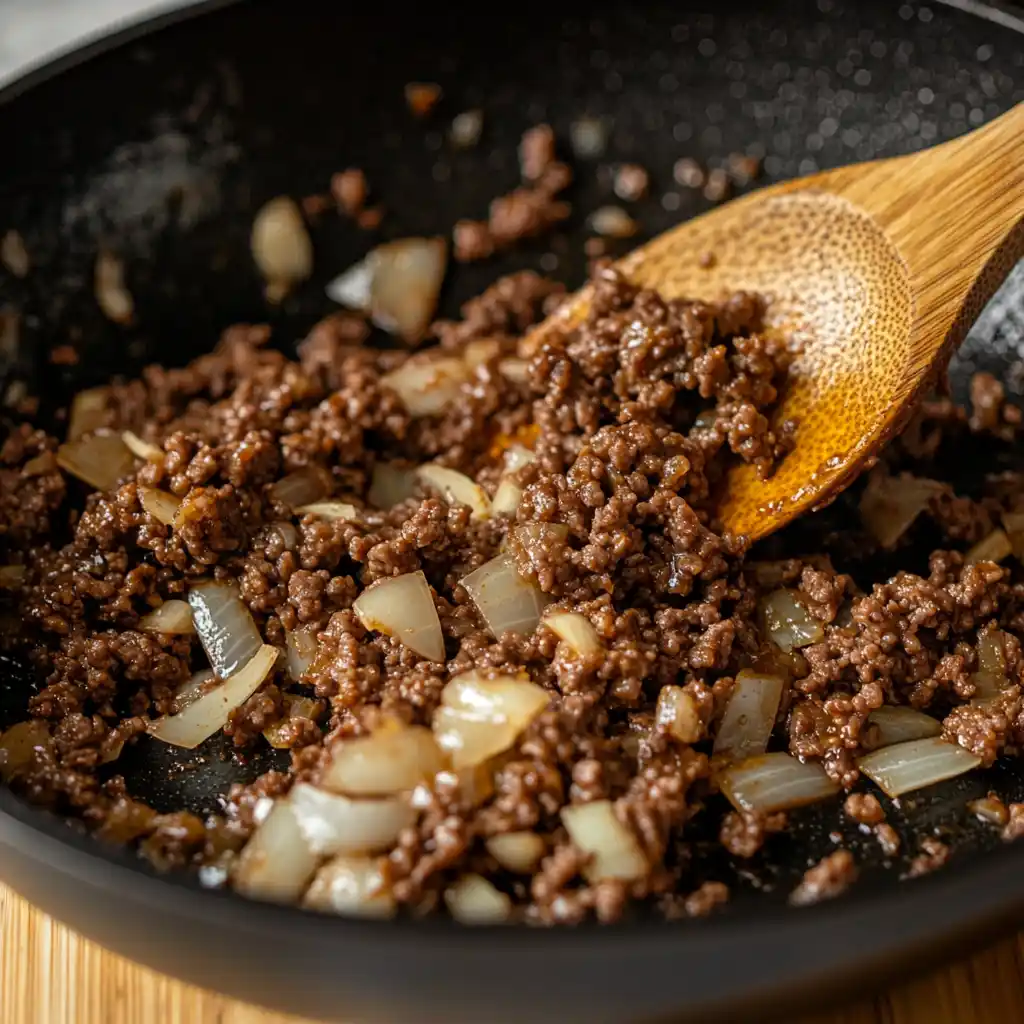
[{"left": 6, "top": 237, "right": 1024, "bottom": 923}]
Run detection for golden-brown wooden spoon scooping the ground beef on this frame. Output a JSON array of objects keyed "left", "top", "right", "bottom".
[{"left": 527, "top": 103, "right": 1024, "bottom": 540}]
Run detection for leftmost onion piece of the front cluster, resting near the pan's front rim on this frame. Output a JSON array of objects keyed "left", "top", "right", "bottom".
[{"left": 232, "top": 798, "right": 319, "bottom": 903}]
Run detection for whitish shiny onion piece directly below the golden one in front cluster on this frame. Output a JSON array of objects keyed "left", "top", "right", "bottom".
[{"left": 289, "top": 782, "right": 416, "bottom": 857}]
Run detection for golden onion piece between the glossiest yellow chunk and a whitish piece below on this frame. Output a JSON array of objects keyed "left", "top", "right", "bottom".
[{"left": 321, "top": 723, "right": 444, "bottom": 797}]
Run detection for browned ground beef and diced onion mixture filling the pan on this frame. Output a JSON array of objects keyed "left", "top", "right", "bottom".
[{"left": 6, "top": 180, "right": 1024, "bottom": 924}]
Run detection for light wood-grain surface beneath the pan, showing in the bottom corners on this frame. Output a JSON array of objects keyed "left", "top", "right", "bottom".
[{"left": 6, "top": 886, "right": 1024, "bottom": 1024}]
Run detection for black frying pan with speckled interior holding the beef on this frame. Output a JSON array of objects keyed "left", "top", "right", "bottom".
[{"left": 0, "top": 0, "right": 1024, "bottom": 1024}]
